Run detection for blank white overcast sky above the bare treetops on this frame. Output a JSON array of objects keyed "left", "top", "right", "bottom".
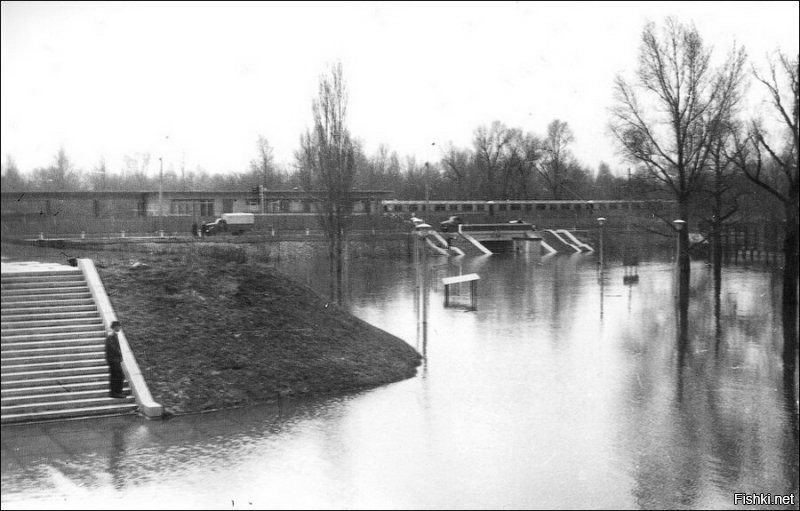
[{"left": 0, "top": 1, "right": 800, "bottom": 179}]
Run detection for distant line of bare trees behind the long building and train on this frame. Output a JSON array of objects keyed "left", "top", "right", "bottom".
[{"left": 2, "top": 127, "right": 641, "bottom": 200}]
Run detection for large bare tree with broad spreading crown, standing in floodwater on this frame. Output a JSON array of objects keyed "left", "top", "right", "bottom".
[{"left": 611, "top": 18, "right": 745, "bottom": 286}]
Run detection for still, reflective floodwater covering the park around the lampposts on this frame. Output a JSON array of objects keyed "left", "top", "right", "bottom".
[{"left": 2, "top": 254, "right": 798, "bottom": 509}]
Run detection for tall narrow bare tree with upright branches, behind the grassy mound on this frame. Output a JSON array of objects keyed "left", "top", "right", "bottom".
[{"left": 299, "top": 63, "right": 357, "bottom": 300}]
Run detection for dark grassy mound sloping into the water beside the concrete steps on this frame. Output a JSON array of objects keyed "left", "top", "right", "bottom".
[{"left": 3, "top": 243, "right": 421, "bottom": 413}]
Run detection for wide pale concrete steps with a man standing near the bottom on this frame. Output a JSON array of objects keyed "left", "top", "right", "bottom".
[{"left": 0, "top": 265, "right": 137, "bottom": 424}]
